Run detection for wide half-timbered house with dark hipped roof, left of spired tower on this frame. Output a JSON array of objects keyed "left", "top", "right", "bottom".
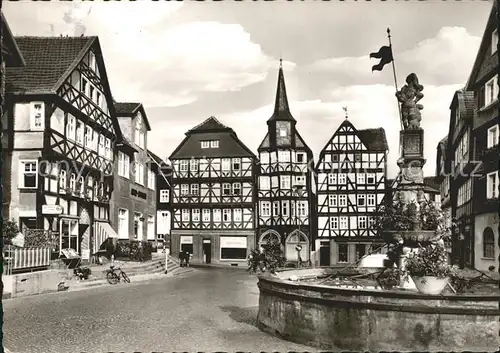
[{"left": 169, "top": 117, "right": 256, "bottom": 265}]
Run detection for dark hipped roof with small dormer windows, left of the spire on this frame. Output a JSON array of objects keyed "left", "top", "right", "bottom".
[{"left": 169, "top": 116, "right": 255, "bottom": 160}]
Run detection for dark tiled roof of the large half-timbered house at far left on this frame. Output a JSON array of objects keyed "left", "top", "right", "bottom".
[{"left": 5, "top": 37, "right": 97, "bottom": 94}]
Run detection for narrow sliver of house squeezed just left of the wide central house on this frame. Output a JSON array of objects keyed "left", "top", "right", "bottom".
[{"left": 148, "top": 151, "right": 172, "bottom": 249}]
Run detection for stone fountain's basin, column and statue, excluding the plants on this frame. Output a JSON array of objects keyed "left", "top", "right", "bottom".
[{"left": 257, "top": 74, "right": 500, "bottom": 352}]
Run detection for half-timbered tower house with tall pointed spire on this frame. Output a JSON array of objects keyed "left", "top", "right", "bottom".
[{"left": 257, "top": 61, "right": 316, "bottom": 262}]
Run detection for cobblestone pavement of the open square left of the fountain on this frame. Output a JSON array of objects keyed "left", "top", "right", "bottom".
[{"left": 3, "top": 268, "right": 314, "bottom": 353}]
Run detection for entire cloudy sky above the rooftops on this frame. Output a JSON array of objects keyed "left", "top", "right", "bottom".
[{"left": 3, "top": 0, "right": 492, "bottom": 177}]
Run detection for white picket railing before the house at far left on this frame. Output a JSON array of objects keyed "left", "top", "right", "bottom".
[{"left": 3, "top": 245, "right": 52, "bottom": 275}]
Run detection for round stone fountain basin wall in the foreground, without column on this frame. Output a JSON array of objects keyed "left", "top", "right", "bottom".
[{"left": 258, "top": 269, "right": 500, "bottom": 352}]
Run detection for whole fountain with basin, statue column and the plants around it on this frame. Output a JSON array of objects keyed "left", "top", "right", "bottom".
[{"left": 251, "top": 74, "right": 500, "bottom": 352}]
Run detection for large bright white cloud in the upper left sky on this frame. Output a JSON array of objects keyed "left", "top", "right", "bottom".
[{"left": 3, "top": 0, "right": 295, "bottom": 107}]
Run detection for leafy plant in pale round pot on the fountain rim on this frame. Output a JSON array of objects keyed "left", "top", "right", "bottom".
[{"left": 405, "top": 242, "right": 456, "bottom": 295}]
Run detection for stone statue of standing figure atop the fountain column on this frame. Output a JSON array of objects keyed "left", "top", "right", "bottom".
[{"left": 396, "top": 73, "right": 424, "bottom": 130}]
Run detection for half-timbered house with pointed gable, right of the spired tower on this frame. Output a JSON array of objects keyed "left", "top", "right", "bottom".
[{"left": 315, "top": 118, "right": 388, "bottom": 266}]
